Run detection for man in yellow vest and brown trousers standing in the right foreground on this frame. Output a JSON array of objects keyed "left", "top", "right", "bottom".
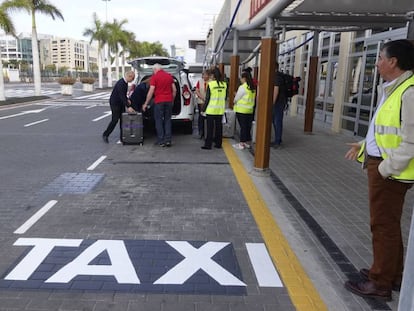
[{"left": 345, "top": 40, "right": 414, "bottom": 301}]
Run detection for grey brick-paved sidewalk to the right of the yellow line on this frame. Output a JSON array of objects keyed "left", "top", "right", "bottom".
[{"left": 258, "top": 117, "right": 414, "bottom": 311}]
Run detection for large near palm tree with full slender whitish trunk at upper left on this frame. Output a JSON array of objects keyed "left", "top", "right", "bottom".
[{"left": 2, "top": 0, "right": 64, "bottom": 96}]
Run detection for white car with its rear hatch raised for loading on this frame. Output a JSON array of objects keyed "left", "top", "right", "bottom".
[{"left": 129, "top": 56, "right": 195, "bottom": 134}]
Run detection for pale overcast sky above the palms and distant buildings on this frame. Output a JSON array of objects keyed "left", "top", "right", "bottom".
[{"left": 10, "top": 0, "right": 225, "bottom": 61}]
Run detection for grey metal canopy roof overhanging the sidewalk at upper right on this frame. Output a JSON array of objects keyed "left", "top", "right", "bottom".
[{"left": 216, "top": 0, "right": 414, "bottom": 64}]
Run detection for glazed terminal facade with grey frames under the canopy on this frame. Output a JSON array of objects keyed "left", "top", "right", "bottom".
[{"left": 290, "top": 28, "right": 407, "bottom": 137}]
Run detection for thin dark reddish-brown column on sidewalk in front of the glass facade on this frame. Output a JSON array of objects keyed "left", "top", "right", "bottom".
[{"left": 304, "top": 56, "right": 318, "bottom": 133}]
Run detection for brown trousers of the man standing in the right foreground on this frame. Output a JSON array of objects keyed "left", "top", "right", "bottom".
[{"left": 367, "top": 159, "right": 412, "bottom": 289}]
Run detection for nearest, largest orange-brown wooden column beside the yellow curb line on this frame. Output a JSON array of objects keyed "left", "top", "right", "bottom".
[{"left": 254, "top": 38, "right": 277, "bottom": 170}]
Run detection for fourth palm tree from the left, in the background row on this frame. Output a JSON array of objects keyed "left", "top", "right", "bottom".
[{"left": 106, "top": 19, "right": 129, "bottom": 83}]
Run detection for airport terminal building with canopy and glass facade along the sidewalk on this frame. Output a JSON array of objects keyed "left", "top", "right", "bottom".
[{"left": 206, "top": 0, "right": 414, "bottom": 136}]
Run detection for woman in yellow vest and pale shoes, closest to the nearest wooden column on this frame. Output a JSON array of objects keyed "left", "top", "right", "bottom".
[{"left": 233, "top": 71, "right": 256, "bottom": 150}]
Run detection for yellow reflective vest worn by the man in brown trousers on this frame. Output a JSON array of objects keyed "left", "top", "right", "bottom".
[{"left": 374, "top": 76, "right": 414, "bottom": 181}]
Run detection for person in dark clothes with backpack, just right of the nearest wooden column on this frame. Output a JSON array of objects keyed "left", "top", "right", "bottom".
[{"left": 272, "top": 62, "right": 288, "bottom": 148}]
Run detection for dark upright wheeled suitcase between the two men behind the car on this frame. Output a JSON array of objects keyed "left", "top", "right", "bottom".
[{"left": 122, "top": 112, "right": 144, "bottom": 145}]
